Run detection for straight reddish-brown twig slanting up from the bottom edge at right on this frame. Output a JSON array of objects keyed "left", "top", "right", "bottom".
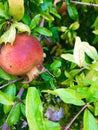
[{"left": 64, "top": 103, "right": 89, "bottom": 130}]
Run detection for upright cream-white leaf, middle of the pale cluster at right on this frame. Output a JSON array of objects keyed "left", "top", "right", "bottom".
[{"left": 74, "top": 37, "right": 85, "bottom": 67}]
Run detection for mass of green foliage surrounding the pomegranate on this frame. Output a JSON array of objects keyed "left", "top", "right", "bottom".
[{"left": 0, "top": 0, "right": 98, "bottom": 130}]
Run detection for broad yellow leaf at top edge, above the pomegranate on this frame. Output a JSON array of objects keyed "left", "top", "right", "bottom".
[{"left": 8, "top": 0, "right": 24, "bottom": 21}]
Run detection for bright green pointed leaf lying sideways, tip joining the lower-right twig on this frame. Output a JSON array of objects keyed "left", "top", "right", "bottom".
[{"left": 43, "top": 88, "right": 85, "bottom": 106}]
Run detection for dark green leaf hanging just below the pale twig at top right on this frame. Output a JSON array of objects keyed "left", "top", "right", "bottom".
[{"left": 67, "top": 4, "right": 78, "bottom": 20}]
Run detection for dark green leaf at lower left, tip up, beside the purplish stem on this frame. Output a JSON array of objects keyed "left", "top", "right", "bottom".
[{"left": 8, "top": 103, "right": 20, "bottom": 126}]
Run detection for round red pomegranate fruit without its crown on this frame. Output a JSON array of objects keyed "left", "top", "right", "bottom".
[{"left": 0, "top": 34, "right": 43, "bottom": 75}]
